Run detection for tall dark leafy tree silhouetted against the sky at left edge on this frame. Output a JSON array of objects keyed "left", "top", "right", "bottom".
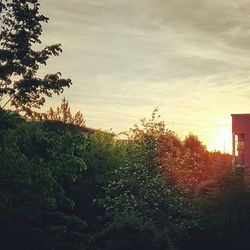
[{"left": 0, "top": 0, "right": 72, "bottom": 115}]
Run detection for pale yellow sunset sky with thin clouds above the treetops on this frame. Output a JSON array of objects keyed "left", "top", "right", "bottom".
[{"left": 38, "top": 0, "right": 250, "bottom": 152}]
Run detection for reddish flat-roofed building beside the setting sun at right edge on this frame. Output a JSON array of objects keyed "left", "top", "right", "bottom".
[{"left": 231, "top": 114, "right": 250, "bottom": 169}]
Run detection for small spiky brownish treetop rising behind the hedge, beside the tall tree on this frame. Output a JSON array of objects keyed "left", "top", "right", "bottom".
[{"left": 38, "top": 97, "right": 85, "bottom": 127}]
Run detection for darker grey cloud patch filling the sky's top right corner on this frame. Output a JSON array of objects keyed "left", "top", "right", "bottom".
[{"left": 136, "top": 0, "right": 250, "bottom": 49}]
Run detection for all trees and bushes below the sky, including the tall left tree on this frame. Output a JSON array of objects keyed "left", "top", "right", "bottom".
[{"left": 0, "top": 0, "right": 250, "bottom": 250}]
